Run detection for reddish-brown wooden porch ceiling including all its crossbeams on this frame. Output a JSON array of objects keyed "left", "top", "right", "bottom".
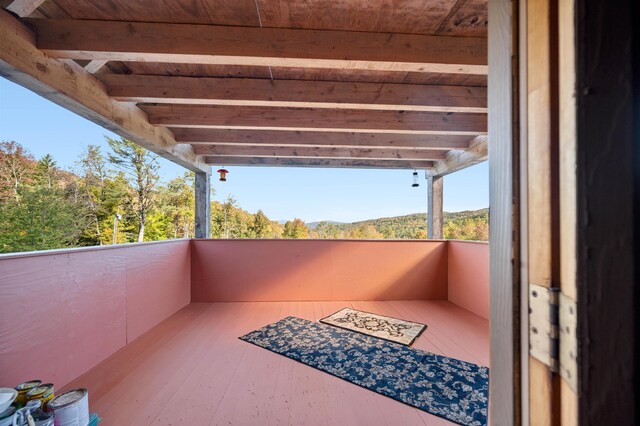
[{"left": 0, "top": 0, "right": 487, "bottom": 170}]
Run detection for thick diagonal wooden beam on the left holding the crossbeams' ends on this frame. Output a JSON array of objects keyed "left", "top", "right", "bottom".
[{"left": 0, "top": 10, "right": 209, "bottom": 172}]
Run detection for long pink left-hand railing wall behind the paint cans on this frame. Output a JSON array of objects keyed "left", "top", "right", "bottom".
[{"left": 0, "top": 240, "right": 190, "bottom": 389}]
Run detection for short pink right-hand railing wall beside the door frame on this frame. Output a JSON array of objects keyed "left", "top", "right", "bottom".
[{"left": 448, "top": 241, "right": 489, "bottom": 319}]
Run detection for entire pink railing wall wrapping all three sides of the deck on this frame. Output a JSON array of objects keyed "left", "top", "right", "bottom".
[{"left": 0, "top": 236, "right": 489, "bottom": 387}]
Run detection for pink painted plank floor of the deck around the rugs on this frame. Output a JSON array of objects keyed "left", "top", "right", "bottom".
[{"left": 66, "top": 301, "right": 489, "bottom": 426}]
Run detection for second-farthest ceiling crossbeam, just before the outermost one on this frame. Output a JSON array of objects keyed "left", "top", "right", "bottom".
[{"left": 194, "top": 145, "right": 446, "bottom": 161}]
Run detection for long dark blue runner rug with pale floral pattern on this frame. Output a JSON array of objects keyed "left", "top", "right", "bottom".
[{"left": 241, "top": 317, "right": 489, "bottom": 426}]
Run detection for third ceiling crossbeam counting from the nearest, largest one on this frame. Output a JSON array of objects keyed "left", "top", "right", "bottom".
[{"left": 140, "top": 104, "right": 487, "bottom": 135}]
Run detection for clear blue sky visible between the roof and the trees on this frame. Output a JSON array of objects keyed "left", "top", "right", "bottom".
[{"left": 0, "top": 78, "right": 489, "bottom": 222}]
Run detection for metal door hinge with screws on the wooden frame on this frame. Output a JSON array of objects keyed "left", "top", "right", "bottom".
[{"left": 529, "top": 284, "right": 577, "bottom": 390}]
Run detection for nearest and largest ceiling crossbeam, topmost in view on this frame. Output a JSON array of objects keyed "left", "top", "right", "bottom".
[{"left": 28, "top": 19, "right": 487, "bottom": 74}]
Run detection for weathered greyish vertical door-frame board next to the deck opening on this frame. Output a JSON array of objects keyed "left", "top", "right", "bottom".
[{"left": 488, "top": 0, "right": 524, "bottom": 425}]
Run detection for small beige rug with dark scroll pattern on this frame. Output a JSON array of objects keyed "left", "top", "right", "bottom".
[{"left": 320, "top": 308, "right": 427, "bottom": 346}]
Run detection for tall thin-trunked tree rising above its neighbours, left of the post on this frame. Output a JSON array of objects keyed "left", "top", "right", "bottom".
[{"left": 107, "top": 138, "right": 160, "bottom": 242}]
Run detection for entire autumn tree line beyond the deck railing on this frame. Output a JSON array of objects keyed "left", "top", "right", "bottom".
[{"left": 0, "top": 138, "right": 488, "bottom": 253}]
